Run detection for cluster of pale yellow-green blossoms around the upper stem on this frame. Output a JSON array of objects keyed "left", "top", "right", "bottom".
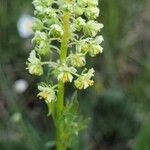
[{"left": 27, "top": 0, "right": 103, "bottom": 103}]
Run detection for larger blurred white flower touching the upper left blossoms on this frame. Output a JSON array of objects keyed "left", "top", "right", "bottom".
[{"left": 17, "top": 14, "right": 34, "bottom": 38}]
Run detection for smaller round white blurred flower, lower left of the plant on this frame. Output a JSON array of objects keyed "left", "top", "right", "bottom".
[{"left": 13, "top": 79, "right": 28, "bottom": 93}]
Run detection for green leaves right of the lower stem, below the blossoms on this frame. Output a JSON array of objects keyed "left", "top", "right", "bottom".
[{"left": 58, "top": 93, "right": 89, "bottom": 147}]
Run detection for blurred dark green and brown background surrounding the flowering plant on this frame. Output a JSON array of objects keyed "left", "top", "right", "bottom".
[{"left": 0, "top": 0, "right": 150, "bottom": 150}]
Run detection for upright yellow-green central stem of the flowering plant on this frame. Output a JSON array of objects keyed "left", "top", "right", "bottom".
[{"left": 56, "top": 13, "right": 70, "bottom": 150}]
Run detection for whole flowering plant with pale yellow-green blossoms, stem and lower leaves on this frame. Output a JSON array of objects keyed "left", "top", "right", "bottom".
[{"left": 27, "top": 0, "right": 103, "bottom": 150}]
